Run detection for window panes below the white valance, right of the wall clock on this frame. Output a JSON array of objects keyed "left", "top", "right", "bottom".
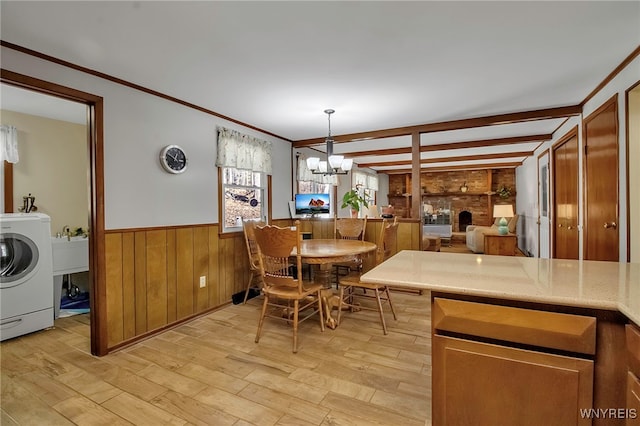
[{"left": 222, "top": 167, "right": 267, "bottom": 232}]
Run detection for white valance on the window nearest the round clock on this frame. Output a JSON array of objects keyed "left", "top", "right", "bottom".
[{"left": 216, "top": 127, "right": 272, "bottom": 175}]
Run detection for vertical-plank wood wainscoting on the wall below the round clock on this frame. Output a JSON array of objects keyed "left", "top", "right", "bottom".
[{"left": 105, "top": 225, "right": 249, "bottom": 350}]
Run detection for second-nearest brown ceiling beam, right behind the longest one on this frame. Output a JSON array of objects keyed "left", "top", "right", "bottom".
[{"left": 339, "top": 133, "right": 552, "bottom": 157}]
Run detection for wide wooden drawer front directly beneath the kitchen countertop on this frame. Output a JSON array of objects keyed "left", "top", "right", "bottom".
[{"left": 432, "top": 298, "right": 596, "bottom": 355}]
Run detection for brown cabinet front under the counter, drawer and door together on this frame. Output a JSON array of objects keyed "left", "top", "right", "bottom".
[{"left": 432, "top": 298, "right": 596, "bottom": 426}]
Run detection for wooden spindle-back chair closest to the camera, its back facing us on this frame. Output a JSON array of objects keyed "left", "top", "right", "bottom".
[{"left": 254, "top": 221, "right": 324, "bottom": 353}]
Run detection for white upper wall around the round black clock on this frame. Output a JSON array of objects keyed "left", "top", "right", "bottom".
[{"left": 1, "top": 47, "right": 291, "bottom": 229}]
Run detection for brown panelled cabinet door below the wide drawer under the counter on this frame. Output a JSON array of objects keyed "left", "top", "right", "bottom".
[{"left": 433, "top": 335, "right": 593, "bottom": 426}]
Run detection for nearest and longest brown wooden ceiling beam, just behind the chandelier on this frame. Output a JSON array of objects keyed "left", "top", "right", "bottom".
[{"left": 292, "top": 105, "right": 582, "bottom": 148}]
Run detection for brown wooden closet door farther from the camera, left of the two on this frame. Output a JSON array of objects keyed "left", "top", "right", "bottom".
[{"left": 552, "top": 128, "right": 579, "bottom": 259}]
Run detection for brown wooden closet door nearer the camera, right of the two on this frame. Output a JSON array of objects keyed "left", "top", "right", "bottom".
[{"left": 583, "top": 96, "right": 620, "bottom": 262}]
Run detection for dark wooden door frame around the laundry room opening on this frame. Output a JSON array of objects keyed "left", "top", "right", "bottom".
[{"left": 0, "top": 69, "right": 107, "bottom": 355}]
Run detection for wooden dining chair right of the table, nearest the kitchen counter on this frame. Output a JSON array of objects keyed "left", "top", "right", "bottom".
[{"left": 338, "top": 217, "right": 398, "bottom": 334}]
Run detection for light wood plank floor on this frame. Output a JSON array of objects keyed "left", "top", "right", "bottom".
[{"left": 0, "top": 292, "right": 431, "bottom": 426}]
